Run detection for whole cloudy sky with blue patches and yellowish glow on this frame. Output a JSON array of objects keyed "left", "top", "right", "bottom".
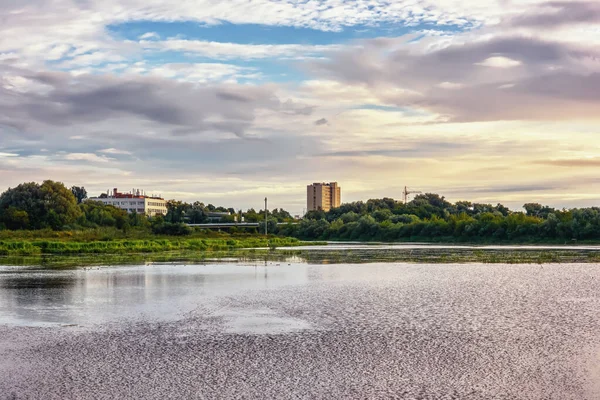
[{"left": 0, "top": 0, "right": 600, "bottom": 214}]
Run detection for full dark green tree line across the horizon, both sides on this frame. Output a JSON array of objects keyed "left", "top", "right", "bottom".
[{"left": 0, "top": 180, "right": 600, "bottom": 243}]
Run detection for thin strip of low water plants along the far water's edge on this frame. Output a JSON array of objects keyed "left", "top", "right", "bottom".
[{"left": 0, "top": 247, "right": 600, "bottom": 268}]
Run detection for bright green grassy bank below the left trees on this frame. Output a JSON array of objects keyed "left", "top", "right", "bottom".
[{"left": 0, "top": 237, "right": 316, "bottom": 256}]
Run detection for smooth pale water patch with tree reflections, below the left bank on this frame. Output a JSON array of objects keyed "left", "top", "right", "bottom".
[{"left": 0, "top": 262, "right": 307, "bottom": 325}]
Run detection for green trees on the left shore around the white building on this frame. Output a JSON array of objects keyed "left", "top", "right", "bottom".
[{"left": 0, "top": 180, "right": 293, "bottom": 235}]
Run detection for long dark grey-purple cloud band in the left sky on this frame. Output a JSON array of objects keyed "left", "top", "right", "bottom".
[{"left": 0, "top": 65, "right": 310, "bottom": 140}]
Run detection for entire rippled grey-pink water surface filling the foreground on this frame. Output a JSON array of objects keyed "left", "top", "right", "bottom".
[{"left": 0, "top": 263, "right": 600, "bottom": 399}]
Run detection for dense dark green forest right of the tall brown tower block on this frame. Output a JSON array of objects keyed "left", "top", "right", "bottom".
[{"left": 279, "top": 193, "right": 600, "bottom": 243}]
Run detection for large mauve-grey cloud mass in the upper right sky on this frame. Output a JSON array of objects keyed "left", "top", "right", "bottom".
[{"left": 308, "top": 36, "right": 600, "bottom": 121}]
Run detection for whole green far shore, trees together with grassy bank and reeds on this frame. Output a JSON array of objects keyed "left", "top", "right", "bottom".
[{"left": 0, "top": 180, "right": 600, "bottom": 265}]
